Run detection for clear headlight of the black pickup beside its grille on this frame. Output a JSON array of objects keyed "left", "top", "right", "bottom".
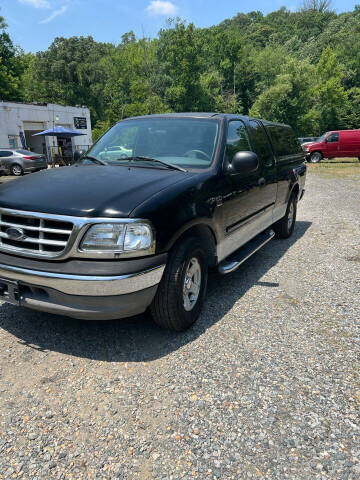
[{"left": 80, "top": 222, "right": 154, "bottom": 253}]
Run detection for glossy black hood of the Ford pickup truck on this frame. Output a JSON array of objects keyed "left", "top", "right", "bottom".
[{"left": 0, "top": 165, "right": 193, "bottom": 217}]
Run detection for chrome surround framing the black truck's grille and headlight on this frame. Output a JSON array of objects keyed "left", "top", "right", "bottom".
[{"left": 0, "top": 208, "right": 155, "bottom": 260}]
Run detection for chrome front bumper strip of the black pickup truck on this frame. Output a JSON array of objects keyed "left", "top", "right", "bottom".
[{"left": 0, "top": 264, "right": 165, "bottom": 297}]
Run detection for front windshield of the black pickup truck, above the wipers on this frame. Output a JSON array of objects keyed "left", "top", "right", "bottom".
[{"left": 87, "top": 117, "right": 219, "bottom": 169}]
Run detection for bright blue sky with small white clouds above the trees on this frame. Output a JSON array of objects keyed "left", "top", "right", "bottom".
[{"left": 0, "top": 0, "right": 360, "bottom": 52}]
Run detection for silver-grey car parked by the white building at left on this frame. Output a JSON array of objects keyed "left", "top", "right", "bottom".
[{"left": 0, "top": 148, "right": 48, "bottom": 177}]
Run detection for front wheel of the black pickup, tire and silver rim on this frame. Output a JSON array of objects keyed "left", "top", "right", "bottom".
[{"left": 150, "top": 237, "right": 208, "bottom": 332}]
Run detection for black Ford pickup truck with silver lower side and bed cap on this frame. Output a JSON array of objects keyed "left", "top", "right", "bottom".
[{"left": 0, "top": 113, "right": 306, "bottom": 331}]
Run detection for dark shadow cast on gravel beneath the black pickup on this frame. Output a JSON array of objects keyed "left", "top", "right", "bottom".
[{"left": 0, "top": 221, "right": 311, "bottom": 362}]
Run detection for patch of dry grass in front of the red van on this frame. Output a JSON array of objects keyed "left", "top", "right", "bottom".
[{"left": 307, "top": 158, "right": 360, "bottom": 181}]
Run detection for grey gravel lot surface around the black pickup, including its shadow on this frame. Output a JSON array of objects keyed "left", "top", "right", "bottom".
[{"left": 0, "top": 175, "right": 360, "bottom": 480}]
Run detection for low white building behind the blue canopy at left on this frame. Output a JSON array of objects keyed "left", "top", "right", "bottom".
[{"left": 0, "top": 102, "right": 92, "bottom": 154}]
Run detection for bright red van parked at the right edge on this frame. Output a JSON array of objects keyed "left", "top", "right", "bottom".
[{"left": 302, "top": 130, "right": 360, "bottom": 163}]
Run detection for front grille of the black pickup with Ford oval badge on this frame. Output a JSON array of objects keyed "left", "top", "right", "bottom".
[{"left": 0, "top": 210, "right": 73, "bottom": 256}]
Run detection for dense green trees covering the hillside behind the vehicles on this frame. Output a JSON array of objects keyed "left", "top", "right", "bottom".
[{"left": 0, "top": 0, "right": 360, "bottom": 137}]
